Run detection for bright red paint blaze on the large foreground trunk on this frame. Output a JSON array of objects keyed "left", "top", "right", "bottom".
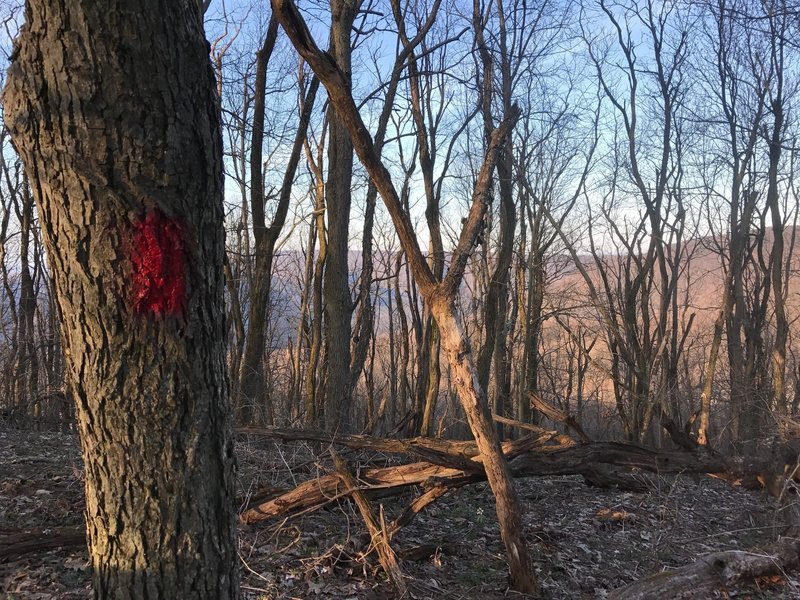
[{"left": 131, "top": 211, "right": 186, "bottom": 317}]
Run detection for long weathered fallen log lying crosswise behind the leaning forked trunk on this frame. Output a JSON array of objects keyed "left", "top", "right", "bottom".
[{"left": 240, "top": 428, "right": 736, "bottom": 524}]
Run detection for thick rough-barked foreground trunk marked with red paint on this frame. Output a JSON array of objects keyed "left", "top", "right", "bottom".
[{"left": 4, "top": 0, "right": 239, "bottom": 600}]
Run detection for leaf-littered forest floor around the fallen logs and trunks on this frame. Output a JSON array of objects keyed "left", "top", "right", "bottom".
[{"left": 0, "top": 430, "right": 800, "bottom": 600}]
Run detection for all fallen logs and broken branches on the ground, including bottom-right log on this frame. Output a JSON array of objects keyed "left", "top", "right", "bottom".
[{"left": 240, "top": 412, "right": 800, "bottom": 600}]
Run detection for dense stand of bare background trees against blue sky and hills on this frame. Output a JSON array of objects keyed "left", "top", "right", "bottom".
[{"left": 0, "top": 0, "right": 800, "bottom": 454}]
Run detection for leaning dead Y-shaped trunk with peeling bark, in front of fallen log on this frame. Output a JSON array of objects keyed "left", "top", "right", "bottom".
[{"left": 272, "top": 0, "right": 537, "bottom": 592}]
